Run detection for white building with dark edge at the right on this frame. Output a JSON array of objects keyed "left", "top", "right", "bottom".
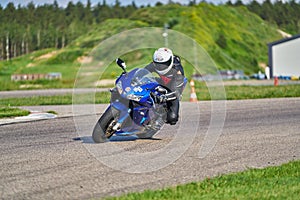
[{"left": 268, "top": 34, "right": 300, "bottom": 78}]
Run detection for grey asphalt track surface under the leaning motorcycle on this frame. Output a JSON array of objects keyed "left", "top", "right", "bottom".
[{"left": 0, "top": 98, "right": 300, "bottom": 199}]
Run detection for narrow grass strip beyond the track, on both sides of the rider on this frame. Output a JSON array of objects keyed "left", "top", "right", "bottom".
[{"left": 0, "top": 82, "right": 300, "bottom": 106}]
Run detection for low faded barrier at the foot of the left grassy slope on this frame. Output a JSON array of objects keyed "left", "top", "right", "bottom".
[{"left": 11, "top": 73, "right": 62, "bottom": 81}]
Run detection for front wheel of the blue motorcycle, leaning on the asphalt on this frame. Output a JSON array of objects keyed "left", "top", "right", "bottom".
[{"left": 92, "top": 109, "right": 116, "bottom": 143}]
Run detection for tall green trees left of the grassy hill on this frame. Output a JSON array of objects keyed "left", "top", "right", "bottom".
[{"left": 0, "top": 0, "right": 138, "bottom": 60}]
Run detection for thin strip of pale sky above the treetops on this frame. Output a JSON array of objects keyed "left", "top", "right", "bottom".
[{"left": 0, "top": 0, "right": 262, "bottom": 7}]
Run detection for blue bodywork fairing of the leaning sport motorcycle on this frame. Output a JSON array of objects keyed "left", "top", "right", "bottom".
[{"left": 111, "top": 69, "right": 163, "bottom": 136}]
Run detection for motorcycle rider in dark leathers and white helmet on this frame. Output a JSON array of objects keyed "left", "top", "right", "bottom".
[{"left": 145, "top": 47, "right": 185, "bottom": 125}]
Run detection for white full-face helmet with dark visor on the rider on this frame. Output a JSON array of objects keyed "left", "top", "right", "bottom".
[{"left": 153, "top": 48, "right": 173, "bottom": 75}]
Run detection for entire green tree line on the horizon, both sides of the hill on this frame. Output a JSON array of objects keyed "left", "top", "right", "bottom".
[{"left": 0, "top": 0, "right": 300, "bottom": 60}]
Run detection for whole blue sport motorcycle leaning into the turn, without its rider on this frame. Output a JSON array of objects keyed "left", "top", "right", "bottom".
[{"left": 92, "top": 58, "right": 176, "bottom": 143}]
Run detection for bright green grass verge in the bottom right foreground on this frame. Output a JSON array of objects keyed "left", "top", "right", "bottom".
[{"left": 108, "top": 161, "right": 300, "bottom": 200}]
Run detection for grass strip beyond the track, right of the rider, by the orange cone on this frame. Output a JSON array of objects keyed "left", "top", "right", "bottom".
[{"left": 196, "top": 82, "right": 300, "bottom": 101}]
